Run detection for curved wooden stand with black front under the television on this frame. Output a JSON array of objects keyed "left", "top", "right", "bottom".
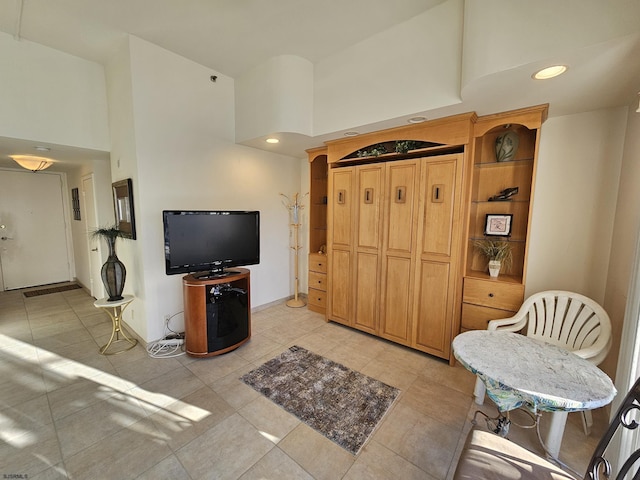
[{"left": 182, "top": 268, "right": 251, "bottom": 357}]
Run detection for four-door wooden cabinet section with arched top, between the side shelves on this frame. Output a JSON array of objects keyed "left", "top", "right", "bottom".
[{"left": 326, "top": 114, "right": 475, "bottom": 359}]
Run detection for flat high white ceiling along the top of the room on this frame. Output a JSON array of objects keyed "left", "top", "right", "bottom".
[{"left": 0, "top": 0, "right": 444, "bottom": 77}]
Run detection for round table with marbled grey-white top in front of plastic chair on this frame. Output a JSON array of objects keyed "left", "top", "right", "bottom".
[{"left": 452, "top": 330, "right": 616, "bottom": 458}]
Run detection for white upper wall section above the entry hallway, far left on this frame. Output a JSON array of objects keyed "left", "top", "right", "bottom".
[{"left": 0, "top": 33, "right": 109, "bottom": 151}]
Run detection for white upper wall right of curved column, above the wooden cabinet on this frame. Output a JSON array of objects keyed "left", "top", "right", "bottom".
[{"left": 313, "top": 0, "right": 463, "bottom": 135}]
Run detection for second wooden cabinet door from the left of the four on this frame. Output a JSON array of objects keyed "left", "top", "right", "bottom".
[{"left": 354, "top": 164, "right": 384, "bottom": 334}]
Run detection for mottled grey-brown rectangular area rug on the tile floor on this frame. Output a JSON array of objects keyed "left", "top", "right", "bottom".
[{"left": 241, "top": 346, "right": 400, "bottom": 455}]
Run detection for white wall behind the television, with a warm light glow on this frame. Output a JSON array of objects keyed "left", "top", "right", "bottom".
[{"left": 109, "top": 37, "right": 300, "bottom": 341}]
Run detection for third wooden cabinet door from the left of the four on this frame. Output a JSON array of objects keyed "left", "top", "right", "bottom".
[{"left": 380, "top": 160, "right": 420, "bottom": 344}]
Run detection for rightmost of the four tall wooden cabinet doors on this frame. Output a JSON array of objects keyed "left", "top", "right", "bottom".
[{"left": 412, "top": 155, "right": 462, "bottom": 358}]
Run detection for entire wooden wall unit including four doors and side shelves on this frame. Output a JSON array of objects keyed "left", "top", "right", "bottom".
[{"left": 309, "top": 106, "right": 546, "bottom": 361}]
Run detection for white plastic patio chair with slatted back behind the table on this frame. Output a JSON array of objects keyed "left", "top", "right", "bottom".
[{"left": 474, "top": 290, "right": 611, "bottom": 435}]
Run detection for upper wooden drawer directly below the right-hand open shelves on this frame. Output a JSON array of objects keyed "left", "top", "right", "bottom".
[{"left": 462, "top": 277, "right": 524, "bottom": 311}]
